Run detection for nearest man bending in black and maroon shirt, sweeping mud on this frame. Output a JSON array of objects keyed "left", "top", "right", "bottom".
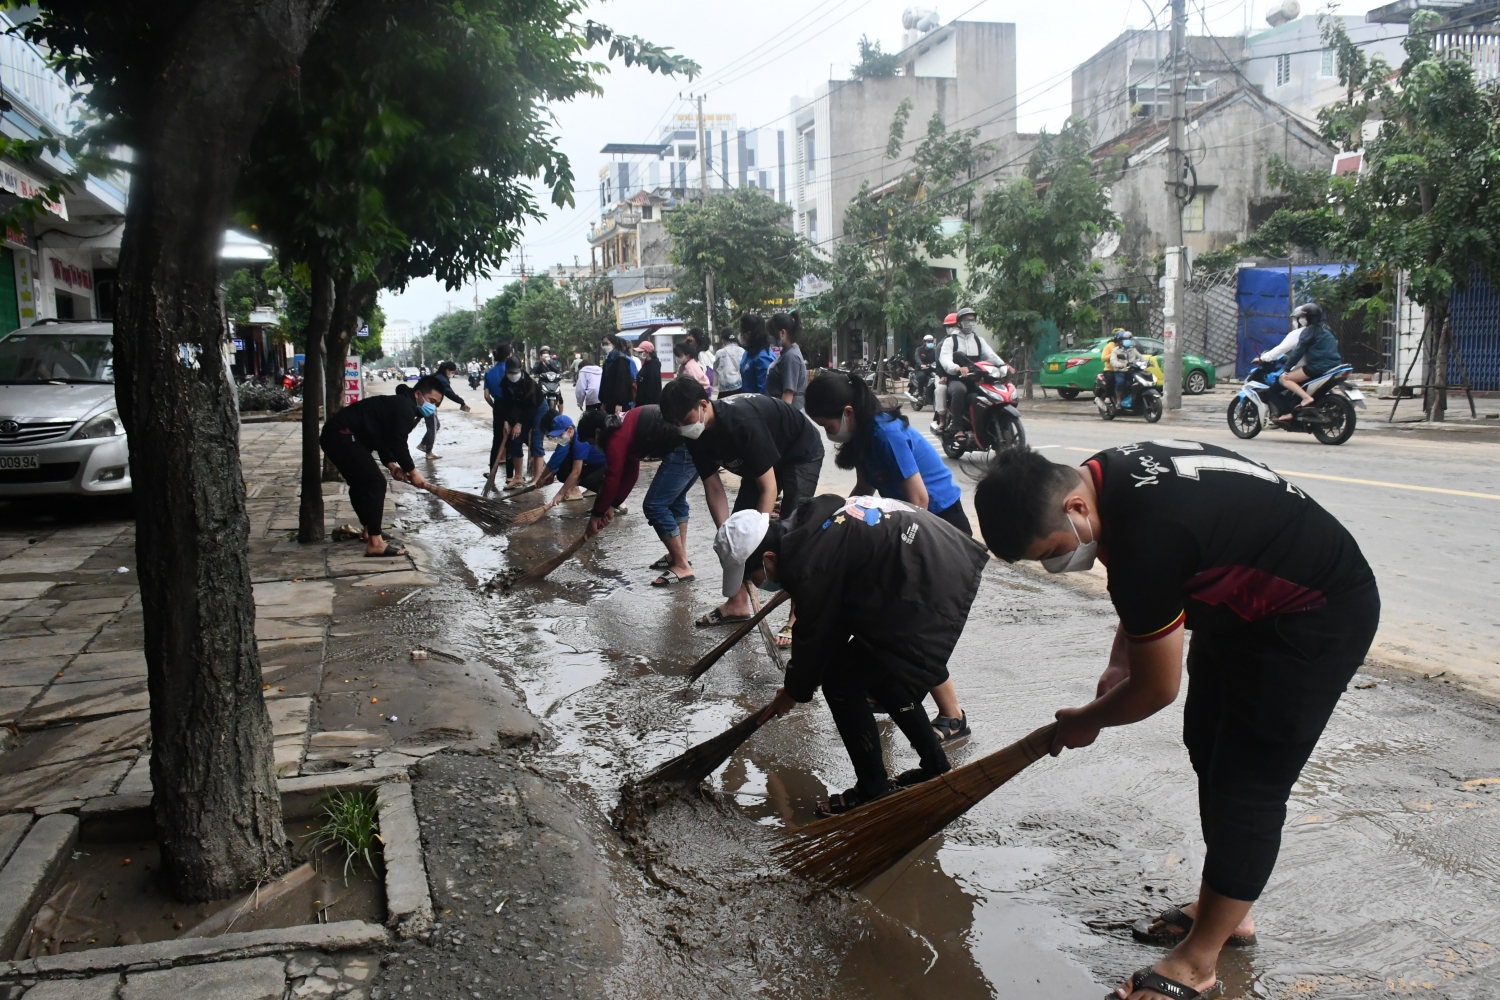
[{"left": 975, "top": 441, "right": 1380, "bottom": 1000}]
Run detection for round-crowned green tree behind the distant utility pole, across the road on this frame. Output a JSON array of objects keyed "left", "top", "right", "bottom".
[{"left": 660, "top": 187, "right": 812, "bottom": 330}]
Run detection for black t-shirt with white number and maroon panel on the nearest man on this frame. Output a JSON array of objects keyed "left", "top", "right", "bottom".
[{"left": 1085, "top": 441, "right": 1376, "bottom": 640}]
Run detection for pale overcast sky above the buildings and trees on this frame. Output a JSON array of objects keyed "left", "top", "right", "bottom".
[{"left": 381, "top": 0, "right": 1266, "bottom": 328}]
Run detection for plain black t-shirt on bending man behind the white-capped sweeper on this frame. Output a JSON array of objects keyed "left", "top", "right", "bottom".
[{"left": 687, "top": 393, "right": 824, "bottom": 480}]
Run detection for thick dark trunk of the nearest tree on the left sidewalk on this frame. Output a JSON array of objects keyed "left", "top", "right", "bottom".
[{"left": 114, "top": 0, "right": 326, "bottom": 901}]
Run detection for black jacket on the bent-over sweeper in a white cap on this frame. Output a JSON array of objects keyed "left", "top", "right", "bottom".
[{"left": 777, "top": 495, "right": 989, "bottom": 702}]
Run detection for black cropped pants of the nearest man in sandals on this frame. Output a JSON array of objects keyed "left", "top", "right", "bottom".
[{"left": 1182, "top": 583, "right": 1380, "bottom": 901}]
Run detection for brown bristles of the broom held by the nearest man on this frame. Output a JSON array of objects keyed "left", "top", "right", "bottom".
[{"left": 774, "top": 723, "right": 1058, "bottom": 889}]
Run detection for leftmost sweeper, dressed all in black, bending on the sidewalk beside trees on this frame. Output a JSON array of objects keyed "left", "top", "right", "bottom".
[{"left": 318, "top": 375, "right": 444, "bottom": 558}]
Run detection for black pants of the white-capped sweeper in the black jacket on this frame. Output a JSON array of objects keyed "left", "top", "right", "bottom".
[{"left": 824, "top": 637, "right": 951, "bottom": 799}]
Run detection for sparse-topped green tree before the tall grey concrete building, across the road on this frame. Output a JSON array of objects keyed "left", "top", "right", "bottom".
[{"left": 818, "top": 99, "right": 993, "bottom": 379}]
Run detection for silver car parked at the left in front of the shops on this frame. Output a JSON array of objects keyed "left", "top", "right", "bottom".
[{"left": 0, "top": 319, "right": 131, "bottom": 496}]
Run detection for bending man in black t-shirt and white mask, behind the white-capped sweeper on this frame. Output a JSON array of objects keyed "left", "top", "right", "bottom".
[{"left": 662, "top": 375, "right": 824, "bottom": 625}]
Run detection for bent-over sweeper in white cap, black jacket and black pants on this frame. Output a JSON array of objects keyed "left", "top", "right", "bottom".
[{"left": 714, "top": 495, "right": 989, "bottom": 814}]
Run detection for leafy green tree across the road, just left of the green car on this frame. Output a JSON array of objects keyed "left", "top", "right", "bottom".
[{"left": 969, "top": 118, "right": 1119, "bottom": 391}]
